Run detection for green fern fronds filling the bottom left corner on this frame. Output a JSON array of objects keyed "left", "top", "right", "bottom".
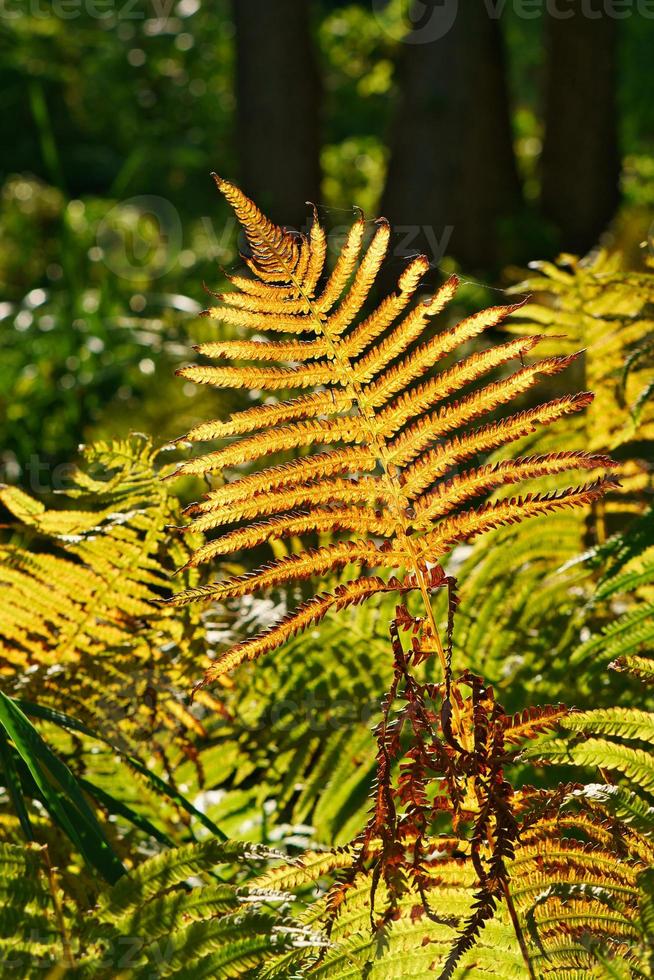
[{"left": 0, "top": 840, "right": 317, "bottom": 980}]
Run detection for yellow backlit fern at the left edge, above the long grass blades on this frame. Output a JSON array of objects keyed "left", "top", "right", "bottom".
[{"left": 0, "top": 436, "right": 219, "bottom": 750}]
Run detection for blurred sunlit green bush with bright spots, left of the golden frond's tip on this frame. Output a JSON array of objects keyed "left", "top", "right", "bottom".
[{"left": 0, "top": 176, "right": 228, "bottom": 470}]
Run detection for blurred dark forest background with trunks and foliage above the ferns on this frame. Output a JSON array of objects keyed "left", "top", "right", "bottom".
[{"left": 0, "top": 0, "right": 654, "bottom": 478}]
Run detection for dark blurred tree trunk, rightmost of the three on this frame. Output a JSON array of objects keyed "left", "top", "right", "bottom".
[{"left": 541, "top": 0, "right": 620, "bottom": 252}]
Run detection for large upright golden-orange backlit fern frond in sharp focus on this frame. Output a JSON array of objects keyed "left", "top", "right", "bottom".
[{"left": 173, "top": 178, "right": 611, "bottom": 679}]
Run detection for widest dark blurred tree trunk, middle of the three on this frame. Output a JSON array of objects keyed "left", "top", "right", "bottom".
[{"left": 381, "top": 0, "right": 521, "bottom": 268}]
